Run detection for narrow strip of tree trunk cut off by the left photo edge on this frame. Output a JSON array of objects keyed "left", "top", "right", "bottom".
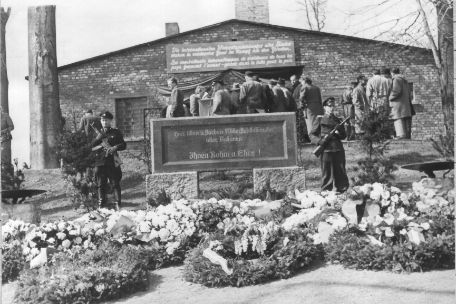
[{"left": 0, "top": 7, "right": 11, "bottom": 164}]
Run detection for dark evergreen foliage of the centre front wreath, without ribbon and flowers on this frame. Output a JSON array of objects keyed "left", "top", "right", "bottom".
[{"left": 184, "top": 229, "right": 323, "bottom": 287}]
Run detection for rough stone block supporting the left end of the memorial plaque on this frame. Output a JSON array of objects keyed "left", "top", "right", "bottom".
[{"left": 146, "top": 172, "right": 198, "bottom": 200}]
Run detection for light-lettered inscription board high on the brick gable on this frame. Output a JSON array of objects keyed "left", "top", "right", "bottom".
[{"left": 166, "top": 40, "right": 296, "bottom": 73}]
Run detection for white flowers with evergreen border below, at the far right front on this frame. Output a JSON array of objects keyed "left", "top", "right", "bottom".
[{"left": 325, "top": 184, "right": 455, "bottom": 272}]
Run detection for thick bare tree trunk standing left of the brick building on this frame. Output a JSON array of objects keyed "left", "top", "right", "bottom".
[{"left": 28, "top": 6, "right": 62, "bottom": 169}]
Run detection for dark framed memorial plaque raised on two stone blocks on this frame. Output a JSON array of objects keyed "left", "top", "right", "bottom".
[{"left": 151, "top": 113, "right": 297, "bottom": 173}]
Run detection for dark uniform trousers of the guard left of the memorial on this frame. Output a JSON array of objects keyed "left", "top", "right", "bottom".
[{"left": 95, "top": 164, "right": 122, "bottom": 207}]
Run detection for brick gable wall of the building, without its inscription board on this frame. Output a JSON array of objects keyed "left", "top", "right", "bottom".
[{"left": 59, "top": 20, "right": 443, "bottom": 139}]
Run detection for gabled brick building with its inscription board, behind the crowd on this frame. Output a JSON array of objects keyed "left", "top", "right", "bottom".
[{"left": 58, "top": 12, "right": 443, "bottom": 147}]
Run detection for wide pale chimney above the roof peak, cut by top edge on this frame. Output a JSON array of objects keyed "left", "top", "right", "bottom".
[{"left": 234, "top": 0, "right": 269, "bottom": 23}]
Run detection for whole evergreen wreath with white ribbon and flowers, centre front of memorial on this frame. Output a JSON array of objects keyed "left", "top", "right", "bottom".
[{"left": 184, "top": 228, "right": 324, "bottom": 287}]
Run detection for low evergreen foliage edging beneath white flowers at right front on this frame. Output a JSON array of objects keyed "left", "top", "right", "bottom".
[{"left": 325, "top": 228, "right": 455, "bottom": 272}]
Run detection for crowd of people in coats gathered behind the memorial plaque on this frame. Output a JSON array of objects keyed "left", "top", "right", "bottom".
[{"left": 163, "top": 68, "right": 414, "bottom": 141}]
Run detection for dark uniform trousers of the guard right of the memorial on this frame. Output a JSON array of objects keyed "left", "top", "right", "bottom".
[{"left": 320, "top": 150, "right": 349, "bottom": 192}]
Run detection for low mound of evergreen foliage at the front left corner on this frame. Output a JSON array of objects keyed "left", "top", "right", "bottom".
[{"left": 15, "top": 242, "right": 149, "bottom": 303}]
